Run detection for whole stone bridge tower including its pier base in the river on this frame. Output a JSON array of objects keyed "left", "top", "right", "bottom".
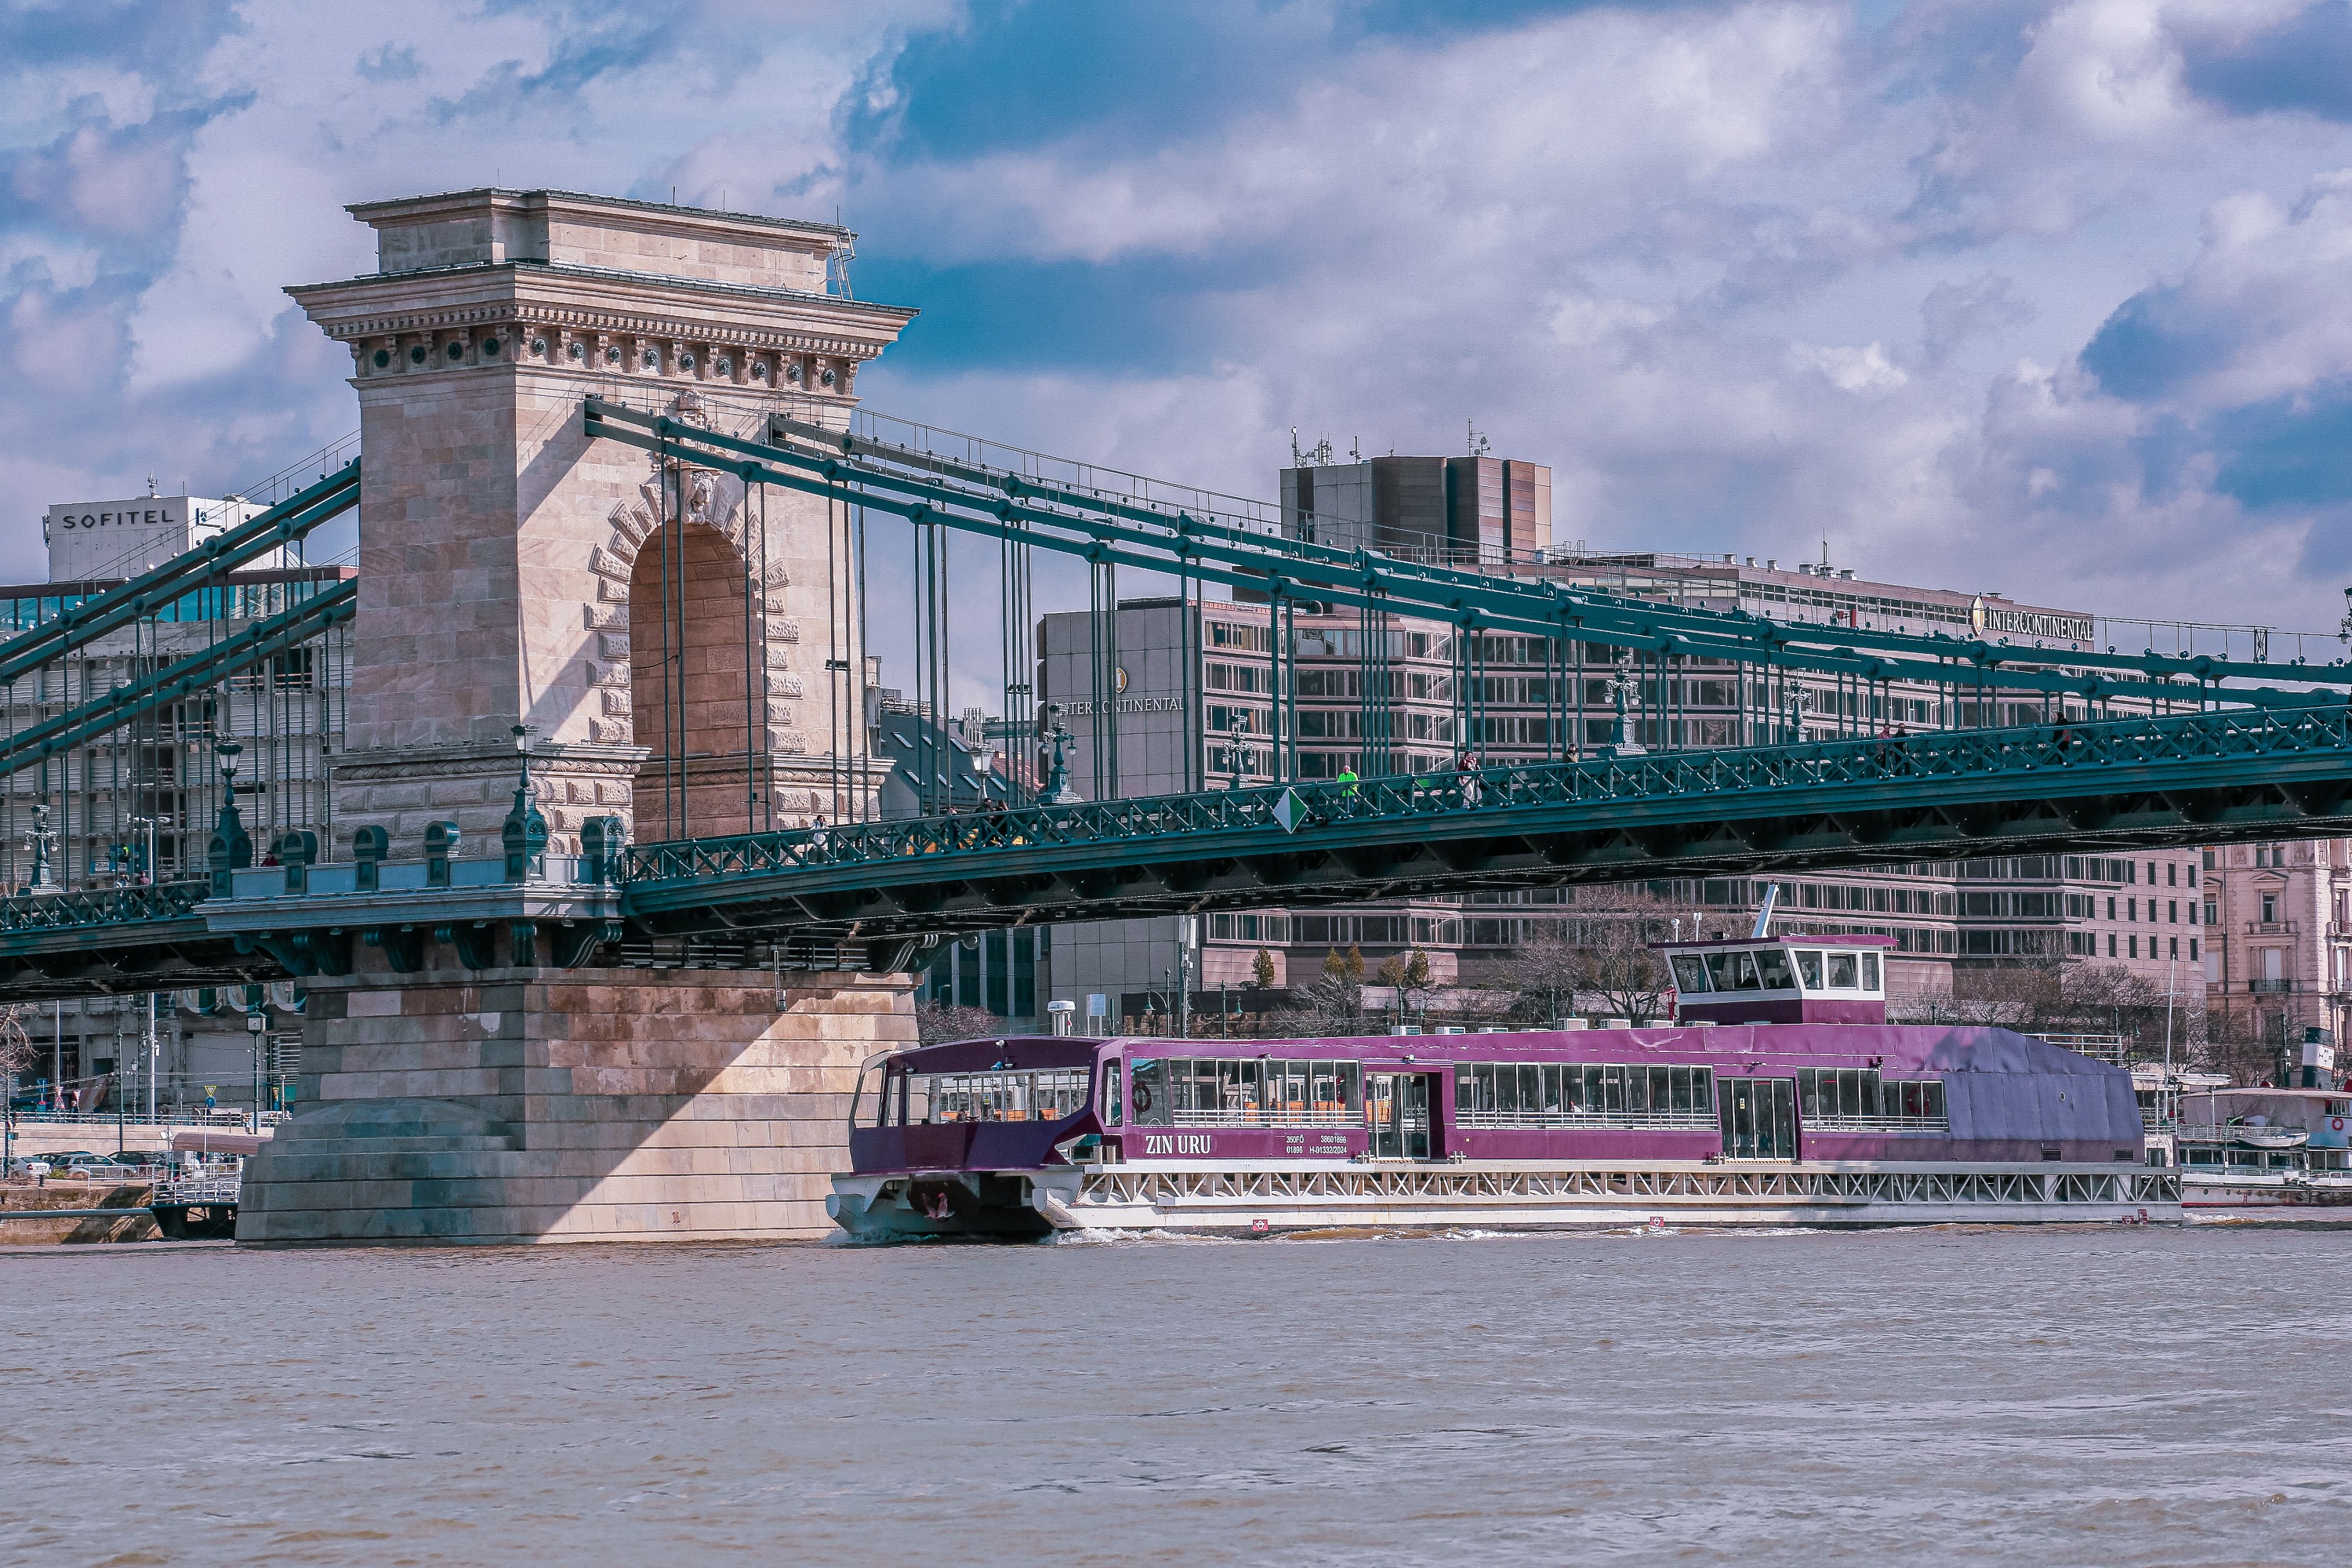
[{"left": 238, "top": 191, "right": 915, "bottom": 1243}]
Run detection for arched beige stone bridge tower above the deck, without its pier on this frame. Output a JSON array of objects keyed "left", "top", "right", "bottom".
[{"left": 289, "top": 191, "right": 913, "bottom": 848}]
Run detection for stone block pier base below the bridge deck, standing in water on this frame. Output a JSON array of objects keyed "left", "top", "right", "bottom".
[{"left": 238, "top": 968, "right": 915, "bottom": 1246}]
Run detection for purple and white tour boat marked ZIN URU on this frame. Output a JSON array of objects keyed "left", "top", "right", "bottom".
[{"left": 826, "top": 935, "right": 2180, "bottom": 1239}]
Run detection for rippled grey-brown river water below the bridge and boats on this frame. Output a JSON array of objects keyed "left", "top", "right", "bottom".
[{"left": 0, "top": 1227, "right": 2352, "bottom": 1568}]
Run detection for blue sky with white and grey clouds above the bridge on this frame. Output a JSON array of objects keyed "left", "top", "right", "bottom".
[{"left": 0, "top": 0, "right": 2352, "bottom": 630}]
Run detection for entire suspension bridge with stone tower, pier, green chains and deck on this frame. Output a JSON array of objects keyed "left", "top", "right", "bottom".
[{"left": 0, "top": 191, "right": 2352, "bottom": 1243}]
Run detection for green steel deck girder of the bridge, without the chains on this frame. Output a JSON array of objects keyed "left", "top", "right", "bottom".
[{"left": 0, "top": 706, "right": 2352, "bottom": 1001}]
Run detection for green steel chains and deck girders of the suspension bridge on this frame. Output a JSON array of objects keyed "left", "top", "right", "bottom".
[{"left": 0, "top": 411, "right": 2352, "bottom": 1001}]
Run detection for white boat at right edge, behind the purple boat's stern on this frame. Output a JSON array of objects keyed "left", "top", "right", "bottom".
[{"left": 2173, "top": 1088, "right": 2352, "bottom": 1220}]
